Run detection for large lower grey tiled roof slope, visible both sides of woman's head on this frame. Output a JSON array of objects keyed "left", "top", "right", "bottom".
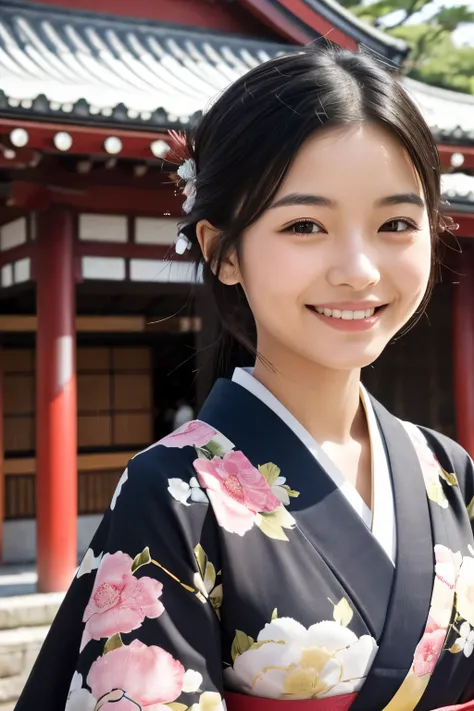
[{"left": 0, "top": 0, "right": 474, "bottom": 149}]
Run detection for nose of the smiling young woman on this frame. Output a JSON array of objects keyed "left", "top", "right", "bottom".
[{"left": 328, "top": 246, "right": 380, "bottom": 291}]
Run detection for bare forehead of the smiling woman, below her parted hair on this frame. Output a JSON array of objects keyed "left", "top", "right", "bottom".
[{"left": 278, "top": 123, "right": 422, "bottom": 199}]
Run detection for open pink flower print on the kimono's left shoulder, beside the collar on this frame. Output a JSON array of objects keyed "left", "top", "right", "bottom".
[{"left": 194, "top": 452, "right": 280, "bottom": 536}]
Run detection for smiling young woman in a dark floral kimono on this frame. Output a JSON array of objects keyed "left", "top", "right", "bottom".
[{"left": 16, "top": 43, "right": 474, "bottom": 711}]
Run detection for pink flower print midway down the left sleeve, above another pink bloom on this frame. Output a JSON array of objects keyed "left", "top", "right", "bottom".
[{"left": 81, "top": 551, "right": 164, "bottom": 651}]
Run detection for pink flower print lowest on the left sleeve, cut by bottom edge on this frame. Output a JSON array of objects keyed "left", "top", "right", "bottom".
[{"left": 87, "top": 640, "right": 184, "bottom": 711}]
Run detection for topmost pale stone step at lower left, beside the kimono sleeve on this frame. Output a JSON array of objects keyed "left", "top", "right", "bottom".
[{"left": 0, "top": 593, "right": 64, "bottom": 632}]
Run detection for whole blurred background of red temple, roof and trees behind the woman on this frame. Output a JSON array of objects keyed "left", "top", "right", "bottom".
[{"left": 0, "top": 0, "right": 474, "bottom": 711}]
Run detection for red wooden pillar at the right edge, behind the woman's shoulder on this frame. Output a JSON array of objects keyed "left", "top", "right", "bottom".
[{"left": 453, "top": 245, "right": 474, "bottom": 457}]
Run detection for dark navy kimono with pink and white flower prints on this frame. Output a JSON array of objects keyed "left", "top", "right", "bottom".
[{"left": 12, "top": 369, "right": 474, "bottom": 711}]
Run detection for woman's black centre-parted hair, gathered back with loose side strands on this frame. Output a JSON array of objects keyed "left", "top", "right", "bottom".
[{"left": 174, "top": 40, "right": 442, "bottom": 362}]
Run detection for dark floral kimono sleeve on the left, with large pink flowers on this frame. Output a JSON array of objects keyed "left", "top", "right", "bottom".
[{"left": 15, "top": 446, "right": 223, "bottom": 711}]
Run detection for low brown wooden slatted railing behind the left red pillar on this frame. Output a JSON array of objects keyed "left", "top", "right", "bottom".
[{"left": 4, "top": 452, "right": 135, "bottom": 520}]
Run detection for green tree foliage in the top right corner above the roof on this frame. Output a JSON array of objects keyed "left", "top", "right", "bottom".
[{"left": 341, "top": 0, "right": 474, "bottom": 94}]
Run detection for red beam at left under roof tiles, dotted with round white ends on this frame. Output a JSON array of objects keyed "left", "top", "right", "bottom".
[{"left": 0, "top": 118, "right": 169, "bottom": 160}]
